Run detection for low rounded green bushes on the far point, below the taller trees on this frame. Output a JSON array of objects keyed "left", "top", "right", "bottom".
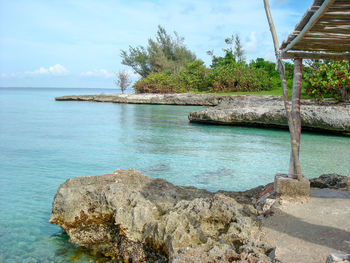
[{"left": 134, "top": 60, "right": 271, "bottom": 93}]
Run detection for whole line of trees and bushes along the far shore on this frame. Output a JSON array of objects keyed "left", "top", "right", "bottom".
[{"left": 115, "top": 26, "right": 350, "bottom": 100}]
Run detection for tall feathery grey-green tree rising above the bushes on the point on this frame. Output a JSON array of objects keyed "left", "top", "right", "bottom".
[{"left": 121, "top": 26, "right": 196, "bottom": 77}]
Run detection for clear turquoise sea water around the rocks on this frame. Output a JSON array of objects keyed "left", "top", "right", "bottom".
[{"left": 0, "top": 88, "right": 350, "bottom": 262}]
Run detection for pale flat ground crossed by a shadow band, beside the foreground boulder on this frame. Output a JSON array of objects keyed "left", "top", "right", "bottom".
[{"left": 263, "top": 189, "right": 350, "bottom": 263}]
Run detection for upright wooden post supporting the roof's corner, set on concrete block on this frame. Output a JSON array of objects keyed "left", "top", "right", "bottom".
[{"left": 289, "top": 58, "right": 303, "bottom": 180}]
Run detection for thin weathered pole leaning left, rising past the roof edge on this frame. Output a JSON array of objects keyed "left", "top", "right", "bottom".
[{"left": 264, "top": 0, "right": 303, "bottom": 180}]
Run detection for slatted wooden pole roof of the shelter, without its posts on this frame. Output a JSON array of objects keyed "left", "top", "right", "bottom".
[{"left": 280, "top": 0, "right": 350, "bottom": 59}]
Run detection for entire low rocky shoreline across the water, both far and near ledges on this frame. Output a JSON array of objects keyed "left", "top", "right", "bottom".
[{"left": 55, "top": 93, "right": 350, "bottom": 136}]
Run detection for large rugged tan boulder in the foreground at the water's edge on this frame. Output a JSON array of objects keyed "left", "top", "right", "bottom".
[{"left": 50, "top": 170, "right": 272, "bottom": 262}]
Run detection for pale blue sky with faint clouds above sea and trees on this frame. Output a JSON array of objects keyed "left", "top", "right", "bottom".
[{"left": 0, "top": 0, "right": 312, "bottom": 88}]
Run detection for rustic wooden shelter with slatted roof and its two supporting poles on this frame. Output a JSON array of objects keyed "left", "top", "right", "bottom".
[{"left": 263, "top": 0, "right": 350, "bottom": 190}]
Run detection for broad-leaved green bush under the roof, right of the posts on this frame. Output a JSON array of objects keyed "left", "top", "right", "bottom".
[{"left": 305, "top": 61, "right": 350, "bottom": 101}]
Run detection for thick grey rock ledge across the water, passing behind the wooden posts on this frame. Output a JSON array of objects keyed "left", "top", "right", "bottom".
[{"left": 188, "top": 96, "right": 350, "bottom": 135}]
